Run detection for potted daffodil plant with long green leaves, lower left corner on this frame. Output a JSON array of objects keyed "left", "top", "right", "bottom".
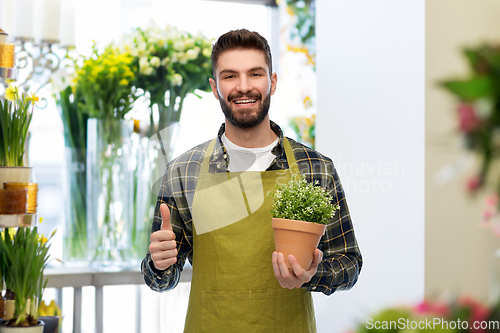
[{"left": 0, "top": 227, "right": 55, "bottom": 333}]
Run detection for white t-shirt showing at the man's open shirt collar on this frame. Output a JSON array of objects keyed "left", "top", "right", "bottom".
[{"left": 221, "top": 133, "right": 279, "bottom": 172}]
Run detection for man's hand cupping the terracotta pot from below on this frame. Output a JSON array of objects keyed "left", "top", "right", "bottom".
[{"left": 273, "top": 249, "right": 323, "bottom": 289}]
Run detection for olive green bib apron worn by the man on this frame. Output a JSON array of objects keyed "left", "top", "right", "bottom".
[{"left": 184, "top": 138, "right": 316, "bottom": 333}]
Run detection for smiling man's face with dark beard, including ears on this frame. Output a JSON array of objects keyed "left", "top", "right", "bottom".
[{"left": 210, "top": 49, "right": 277, "bottom": 128}]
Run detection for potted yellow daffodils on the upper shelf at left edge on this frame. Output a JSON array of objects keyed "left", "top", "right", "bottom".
[{"left": 0, "top": 83, "right": 38, "bottom": 184}]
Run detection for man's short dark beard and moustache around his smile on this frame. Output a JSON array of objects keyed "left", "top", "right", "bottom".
[{"left": 217, "top": 89, "right": 271, "bottom": 128}]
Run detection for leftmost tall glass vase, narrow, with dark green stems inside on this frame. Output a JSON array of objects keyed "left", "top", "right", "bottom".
[{"left": 63, "top": 147, "right": 88, "bottom": 266}]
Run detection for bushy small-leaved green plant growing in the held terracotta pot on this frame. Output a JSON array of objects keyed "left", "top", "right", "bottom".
[{"left": 267, "top": 175, "right": 340, "bottom": 224}]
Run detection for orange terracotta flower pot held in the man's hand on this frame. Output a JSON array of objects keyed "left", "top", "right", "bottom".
[{"left": 272, "top": 218, "right": 326, "bottom": 270}]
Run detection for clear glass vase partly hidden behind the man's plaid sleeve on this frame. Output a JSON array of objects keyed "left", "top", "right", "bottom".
[{"left": 132, "top": 122, "right": 179, "bottom": 262}]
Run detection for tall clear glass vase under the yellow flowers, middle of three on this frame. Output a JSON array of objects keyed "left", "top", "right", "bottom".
[{"left": 87, "top": 118, "right": 134, "bottom": 268}]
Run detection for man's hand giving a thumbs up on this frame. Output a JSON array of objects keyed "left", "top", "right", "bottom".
[{"left": 149, "top": 203, "right": 177, "bottom": 270}]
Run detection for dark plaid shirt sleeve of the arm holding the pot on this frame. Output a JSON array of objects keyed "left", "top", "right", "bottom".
[{"left": 302, "top": 164, "right": 363, "bottom": 295}]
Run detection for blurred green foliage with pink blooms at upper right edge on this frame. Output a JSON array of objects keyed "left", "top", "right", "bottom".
[{"left": 438, "top": 43, "right": 500, "bottom": 213}]
